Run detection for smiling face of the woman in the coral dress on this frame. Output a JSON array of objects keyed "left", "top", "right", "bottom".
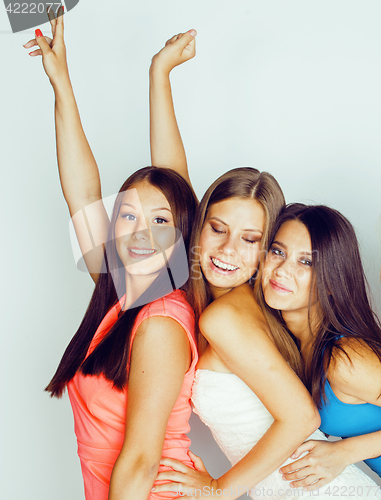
[{"left": 115, "top": 181, "right": 176, "bottom": 276}]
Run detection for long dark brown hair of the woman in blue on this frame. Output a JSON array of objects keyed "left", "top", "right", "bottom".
[{"left": 263, "top": 203, "right": 381, "bottom": 407}]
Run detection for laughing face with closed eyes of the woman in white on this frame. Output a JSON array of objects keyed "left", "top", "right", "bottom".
[{"left": 200, "top": 198, "right": 265, "bottom": 298}]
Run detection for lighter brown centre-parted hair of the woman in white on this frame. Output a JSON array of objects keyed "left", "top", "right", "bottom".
[{"left": 188, "top": 167, "right": 285, "bottom": 353}]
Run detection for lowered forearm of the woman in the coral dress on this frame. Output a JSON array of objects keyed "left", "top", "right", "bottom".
[{"left": 108, "top": 454, "right": 159, "bottom": 500}]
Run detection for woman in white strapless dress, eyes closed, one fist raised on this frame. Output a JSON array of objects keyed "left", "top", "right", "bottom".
[{"left": 150, "top": 32, "right": 381, "bottom": 499}]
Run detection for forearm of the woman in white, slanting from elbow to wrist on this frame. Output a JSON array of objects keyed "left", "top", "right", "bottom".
[{"left": 217, "top": 421, "right": 317, "bottom": 499}]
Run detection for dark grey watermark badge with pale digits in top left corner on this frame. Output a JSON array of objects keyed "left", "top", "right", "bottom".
[{"left": 1, "top": 0, "right": 79, "bottom": 34}]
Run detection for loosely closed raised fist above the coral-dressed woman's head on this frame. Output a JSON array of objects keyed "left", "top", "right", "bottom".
[{"left": 151, "top": 30, "right": 197, "bottom": 74}]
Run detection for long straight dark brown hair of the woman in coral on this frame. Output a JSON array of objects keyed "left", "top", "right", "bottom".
[{"left": 45, "top": 167, "right": 197, "bottom": 397}]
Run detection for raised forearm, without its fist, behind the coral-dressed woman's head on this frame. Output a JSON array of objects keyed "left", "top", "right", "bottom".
[{"left": 150, "top": 63, "right": 189, "bottom": 181}]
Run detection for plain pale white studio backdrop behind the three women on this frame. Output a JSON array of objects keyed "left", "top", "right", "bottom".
[{"left": 0, "top": 0, "right": 381, "bottom": 500}]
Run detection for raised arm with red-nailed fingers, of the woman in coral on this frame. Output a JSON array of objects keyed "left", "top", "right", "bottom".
[{"left": 24, "top": 7, "right": 109, "bottom": 282}]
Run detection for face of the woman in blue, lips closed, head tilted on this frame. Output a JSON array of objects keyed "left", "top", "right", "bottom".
[{"left": 262, "top": 220, "right": 312, "bottom": 314}]
